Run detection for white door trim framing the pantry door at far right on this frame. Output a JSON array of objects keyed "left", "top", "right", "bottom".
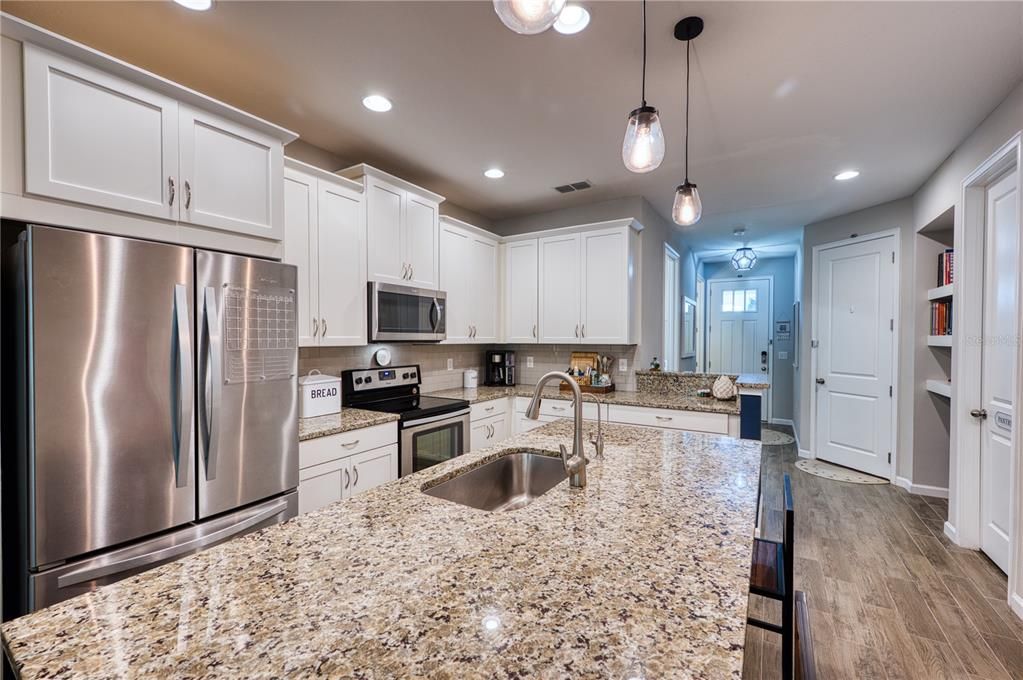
[{"left": 945, "top": 133, "right": 1023, "bottom": 618}]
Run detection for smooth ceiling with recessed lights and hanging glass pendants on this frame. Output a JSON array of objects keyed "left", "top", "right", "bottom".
[{"left": 9, "top": 0, "right": 1023, "bottom": 251}]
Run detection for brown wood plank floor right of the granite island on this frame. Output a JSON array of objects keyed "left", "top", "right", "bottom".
[{"left": 743, "top": 427, "right": 1023, "bottom": 680}]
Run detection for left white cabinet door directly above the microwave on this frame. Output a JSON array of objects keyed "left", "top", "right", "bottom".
[{"left": 365, "top": 179, "right": 407, "bottom": 283}]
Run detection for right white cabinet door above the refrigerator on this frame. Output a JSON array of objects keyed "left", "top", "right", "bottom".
[{"left": 178, "top": 104, "right": 284, "bottom": 240}]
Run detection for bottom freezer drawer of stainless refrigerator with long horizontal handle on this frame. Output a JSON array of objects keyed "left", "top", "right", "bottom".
[{"left": 29, "top": 491, "right": 299, "bottom": 611}]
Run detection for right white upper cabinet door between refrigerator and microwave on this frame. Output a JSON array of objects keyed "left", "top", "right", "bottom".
[{"left": 317, "top": 181, "right": 366, "bottom": 346}]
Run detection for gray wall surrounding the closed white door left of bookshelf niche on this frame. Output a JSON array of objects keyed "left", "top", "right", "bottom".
[{"left": 794, "top": 198, "right": 916, "bottom": 479}]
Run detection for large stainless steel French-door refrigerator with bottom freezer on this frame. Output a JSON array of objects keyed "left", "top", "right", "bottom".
[{"left": 3, "top": 226, "right": 299, "bottom": 617}]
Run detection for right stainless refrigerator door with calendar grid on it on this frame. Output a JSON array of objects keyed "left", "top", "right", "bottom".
[{"left": 195, "top": 251, "right": 299, "bottom": 519}]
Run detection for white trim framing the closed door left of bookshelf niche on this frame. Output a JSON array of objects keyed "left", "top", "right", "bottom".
[{"left": 803, "top": 229, "right": 902, "bottom": 484}]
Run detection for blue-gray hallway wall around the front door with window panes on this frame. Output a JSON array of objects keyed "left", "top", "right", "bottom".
[{"left": 703, "top": 257, "right": 796, "bottom": 420}]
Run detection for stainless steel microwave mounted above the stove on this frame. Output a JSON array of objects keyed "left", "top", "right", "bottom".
[{"left": 369, "top": 281, "right": 447, "bottom": 343}]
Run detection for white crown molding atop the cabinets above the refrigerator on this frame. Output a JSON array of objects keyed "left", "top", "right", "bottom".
[{"left": 0, "top": 12, "right": 299, "bottom": 144}]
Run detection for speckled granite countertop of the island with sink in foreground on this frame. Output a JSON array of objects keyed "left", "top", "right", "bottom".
[{"left": 2, "top": 421, "right": 760, "bottom": 679}]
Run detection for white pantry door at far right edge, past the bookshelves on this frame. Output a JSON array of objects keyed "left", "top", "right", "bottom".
[{"left": 980, "top": 166, "right": 1020, "bottom": 572}]
